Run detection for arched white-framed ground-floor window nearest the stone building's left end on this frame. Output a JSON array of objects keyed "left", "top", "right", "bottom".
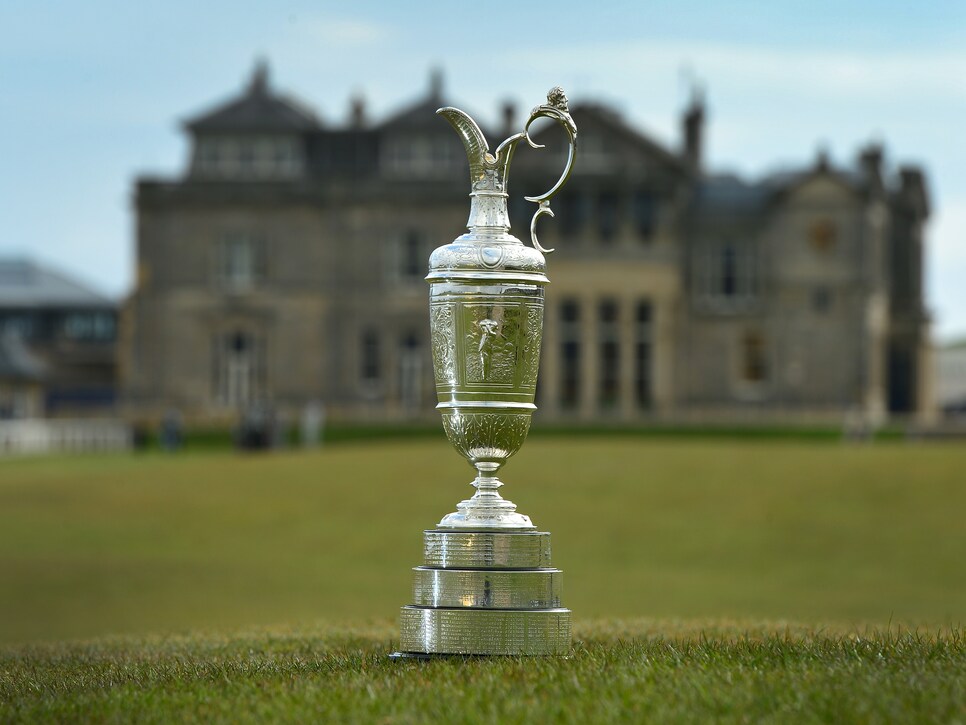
[{"left": 213, "top": 330, "right": 265, "bottom": 408}]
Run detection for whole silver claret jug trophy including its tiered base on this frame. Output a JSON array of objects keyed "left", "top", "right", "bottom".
[{"left": 396, "top": 87, "right": 577, "bottom": 657}]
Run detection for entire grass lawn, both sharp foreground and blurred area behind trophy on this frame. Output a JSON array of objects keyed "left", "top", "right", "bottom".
[{"left": 0, "top": 436, "right": 966, "bottom": 722}]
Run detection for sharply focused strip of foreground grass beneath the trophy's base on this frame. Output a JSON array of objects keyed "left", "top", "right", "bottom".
[{"left": 0, "top": 621, "right": 966, "bottom": 723}]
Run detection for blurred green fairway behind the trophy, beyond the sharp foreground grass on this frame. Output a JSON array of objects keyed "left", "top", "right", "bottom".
[{"left": 0, "top": 437, "right": 966, "bottom": 642}]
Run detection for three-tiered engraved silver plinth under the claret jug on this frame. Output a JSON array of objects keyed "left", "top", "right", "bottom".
[{"left": 398, "top": 529, "right": 570, "bottom": 656}]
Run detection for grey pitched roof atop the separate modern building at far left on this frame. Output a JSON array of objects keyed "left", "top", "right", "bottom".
[{"left": 0, "top": 259, "right": 115, "bottom": 309}]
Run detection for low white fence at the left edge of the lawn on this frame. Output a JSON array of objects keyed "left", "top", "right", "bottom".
[{"left": 0, "top": 419, "right": 131, "bottom": 456}]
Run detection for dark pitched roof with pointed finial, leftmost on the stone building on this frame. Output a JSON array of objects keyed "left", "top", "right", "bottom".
[{"left": 185, "top": 63, "right": 319, "bottom": 132}]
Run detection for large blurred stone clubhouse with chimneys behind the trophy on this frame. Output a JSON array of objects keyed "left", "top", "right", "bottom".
[{"left": 121, "top": 66, "right": 931, "bottom": 421}]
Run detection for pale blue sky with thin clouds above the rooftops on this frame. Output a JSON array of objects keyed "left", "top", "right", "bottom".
[{"left": 0, "top": 0, "right": 966, "bottom": 340}]
